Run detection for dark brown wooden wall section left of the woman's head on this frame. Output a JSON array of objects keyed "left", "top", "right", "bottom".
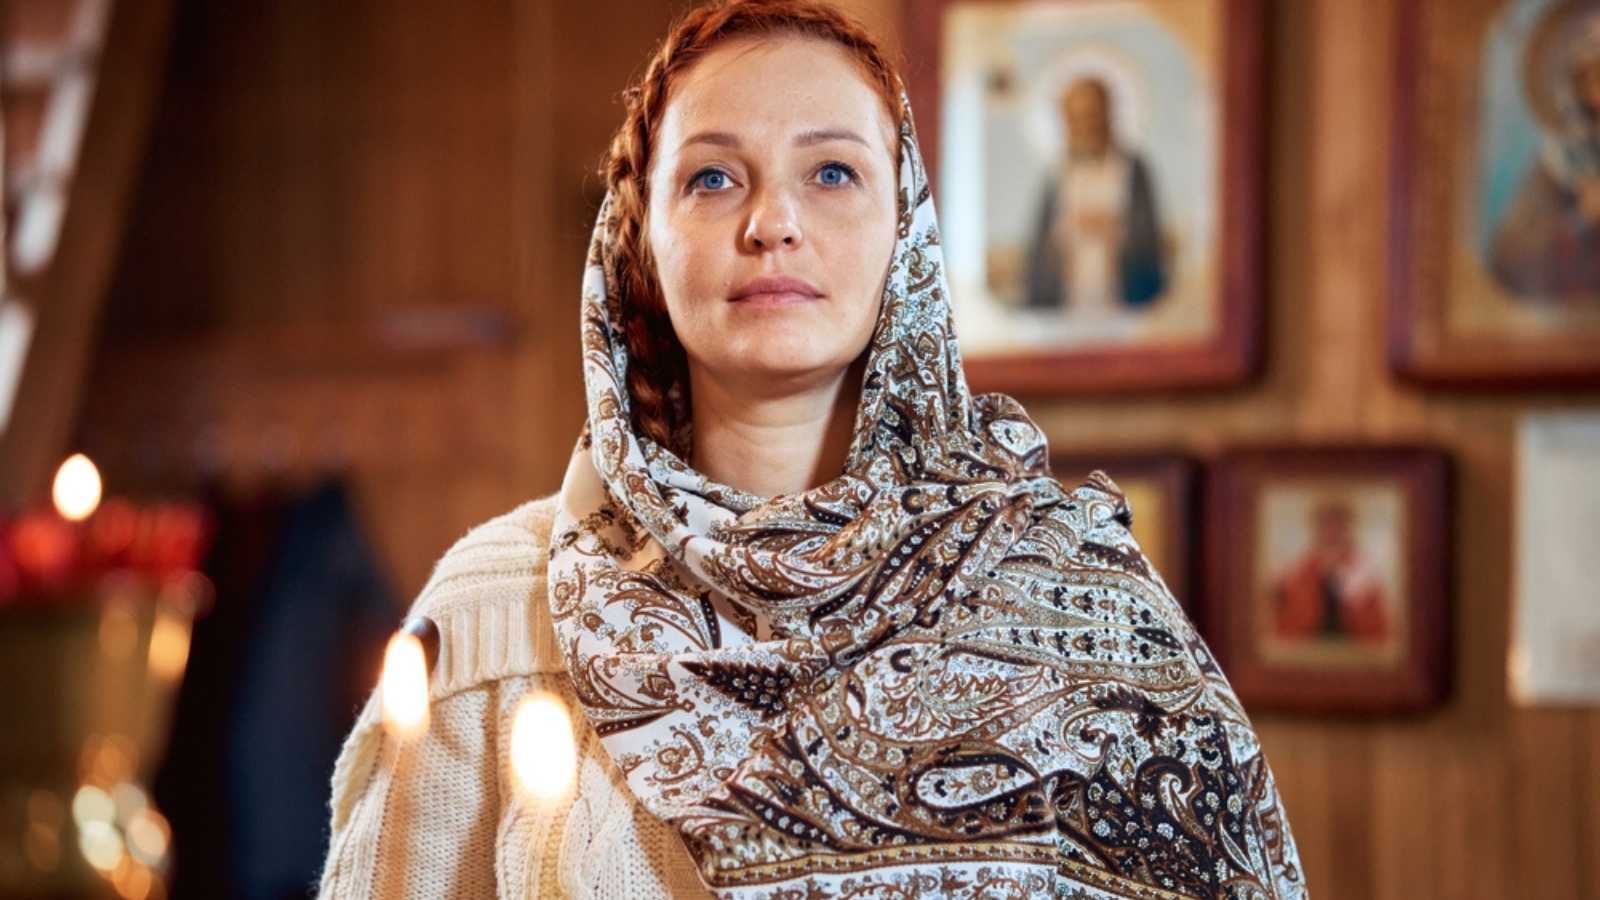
[{"left": 78, "top": 0, "right": 674, "bottom": 596}]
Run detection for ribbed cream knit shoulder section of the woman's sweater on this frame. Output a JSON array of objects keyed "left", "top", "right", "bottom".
[{"left": 408, "top": 495, "right": 563, "bottom": 701}]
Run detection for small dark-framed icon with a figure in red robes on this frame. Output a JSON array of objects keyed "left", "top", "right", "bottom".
[{"left": 1202, "top": 447, "right": 1450, "bottom": 713}]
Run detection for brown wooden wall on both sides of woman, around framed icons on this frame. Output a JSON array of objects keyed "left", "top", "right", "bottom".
[{"left": 82, "top": 0, "right": 1600, "bottom": 900}]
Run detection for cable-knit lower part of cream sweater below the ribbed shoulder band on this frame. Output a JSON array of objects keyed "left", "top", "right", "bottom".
[{"left": 320, "top": 673, "right": 709, "bottom": 900}]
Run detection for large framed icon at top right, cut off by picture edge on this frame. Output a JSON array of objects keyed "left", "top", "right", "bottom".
[{"left": 1390, "top": 0, "right": 1600, "bottom": 386}]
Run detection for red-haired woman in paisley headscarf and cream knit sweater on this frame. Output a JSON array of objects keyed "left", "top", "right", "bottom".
[{"left": 323, "top": 0, "right": 1304, "bottom": 897}]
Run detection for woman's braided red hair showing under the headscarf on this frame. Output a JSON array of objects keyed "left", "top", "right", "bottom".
[{"left": 600, "top": 0, "right": 902, "bottom": 455}]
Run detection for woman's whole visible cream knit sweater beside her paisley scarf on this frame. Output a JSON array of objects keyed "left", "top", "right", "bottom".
[{"left": 320, "top": 496, "right": 709, "bottom": 900}]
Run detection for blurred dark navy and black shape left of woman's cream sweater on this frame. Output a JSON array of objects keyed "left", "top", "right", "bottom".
[{"left": 155, "top": 480, "right": 398, "bottom": 900}]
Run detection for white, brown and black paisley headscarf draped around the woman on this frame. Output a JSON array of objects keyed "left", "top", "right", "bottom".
[{"left": 549, "top": 93, "right": 1304, "bottom": 898}]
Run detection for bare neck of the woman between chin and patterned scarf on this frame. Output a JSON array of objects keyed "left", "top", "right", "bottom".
[{"left": 690, "top": 359, "right": 866, "bottom": 496}]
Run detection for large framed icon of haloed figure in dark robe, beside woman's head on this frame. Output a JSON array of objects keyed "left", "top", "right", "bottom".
[{"left": 912, "top": 0, "right": 1262, "bottom": 394}]
